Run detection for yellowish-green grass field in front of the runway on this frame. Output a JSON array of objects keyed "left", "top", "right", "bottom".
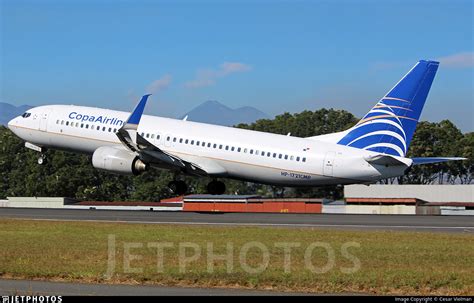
[{"left": 0, "top": 220, "right": 474, "bottom": 295}]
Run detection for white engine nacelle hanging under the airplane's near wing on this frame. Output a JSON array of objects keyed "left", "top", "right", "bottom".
[{"left": 92, "top": 146, "right": 147, "bottom": 175}]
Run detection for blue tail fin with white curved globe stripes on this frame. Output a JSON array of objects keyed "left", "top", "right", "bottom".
[{"left": 338, "top": 60, "right": 439, "bottom": 157}]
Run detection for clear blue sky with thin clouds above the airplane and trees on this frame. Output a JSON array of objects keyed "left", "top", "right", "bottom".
[{"left": 0, "top": 0, "right": 474, "bottom": 131}]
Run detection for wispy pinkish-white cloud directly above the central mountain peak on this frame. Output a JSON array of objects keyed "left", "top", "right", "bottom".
[{"left": 185, "top": 62, "right": 252, "bottom": 88}]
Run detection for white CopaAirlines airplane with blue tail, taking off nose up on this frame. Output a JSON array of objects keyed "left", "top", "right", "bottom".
[{"left": 8, "top": 60, "right": 465, "bottom": 195}]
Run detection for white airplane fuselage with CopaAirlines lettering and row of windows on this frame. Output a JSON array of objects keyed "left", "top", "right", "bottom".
[{"left": 8, "top": 105, "right": 404, "bottom": 186}]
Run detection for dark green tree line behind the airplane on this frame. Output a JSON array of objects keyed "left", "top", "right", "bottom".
[{"left": 0, "top": 109, "right": 474, "bottom": 201}]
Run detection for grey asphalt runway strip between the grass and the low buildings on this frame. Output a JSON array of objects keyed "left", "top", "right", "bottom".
[{"left": 0, "top": 208, "right": 474, "bottom": 234}]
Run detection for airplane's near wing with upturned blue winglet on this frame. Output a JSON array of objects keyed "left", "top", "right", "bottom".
[{"left": 116, "top": 95, "right": 222, "bottom": 176}]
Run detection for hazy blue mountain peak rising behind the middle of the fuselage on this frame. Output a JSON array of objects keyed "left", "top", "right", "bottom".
[{"left": 181, "top": 101, "right": 269, "bottom": 126}]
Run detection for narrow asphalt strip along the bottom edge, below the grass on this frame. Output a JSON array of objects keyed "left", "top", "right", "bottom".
[{"left": 0, "top": 280, "right": 312, "bottom": 296}]
